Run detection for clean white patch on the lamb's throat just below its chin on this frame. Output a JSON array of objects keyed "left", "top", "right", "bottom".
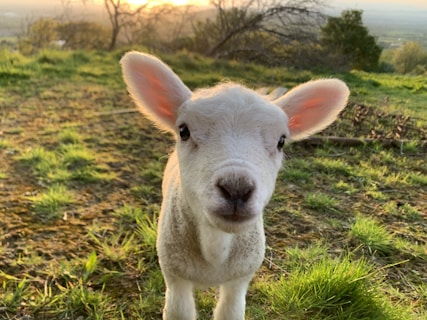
[{"left": 199, "top": 225, "right": 235, "bottom": 265}]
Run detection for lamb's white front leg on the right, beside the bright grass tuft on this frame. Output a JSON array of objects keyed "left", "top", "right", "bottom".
[{"left": 214, "top": 276, "right": 252, "bottom": 320}]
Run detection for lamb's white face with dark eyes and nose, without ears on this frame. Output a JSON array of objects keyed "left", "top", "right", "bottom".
[{"left": 176, "top": 85, "right": 289, "bottom": 232}]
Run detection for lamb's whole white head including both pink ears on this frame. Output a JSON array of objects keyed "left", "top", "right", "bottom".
[{"left": 122, "top": 52, "right": 349, "bottom": 232}]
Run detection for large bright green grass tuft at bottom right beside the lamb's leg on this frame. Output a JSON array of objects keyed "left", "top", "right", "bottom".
[{"left": 260, "top": 257, "right": 407, "bottom": 320}]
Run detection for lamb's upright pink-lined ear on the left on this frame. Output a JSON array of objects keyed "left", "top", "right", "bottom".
[{"left": 120, "top": 52, "right": 191, "bottom": 131}]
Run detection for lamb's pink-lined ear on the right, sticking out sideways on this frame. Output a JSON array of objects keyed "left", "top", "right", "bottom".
[{"left": 274, "top": 79, "right": 350, "bottom": 141}]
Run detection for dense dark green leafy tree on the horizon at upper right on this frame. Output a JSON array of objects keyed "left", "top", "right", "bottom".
[{"left": 321, "top": 10, "right": 382, "bottom": 70}]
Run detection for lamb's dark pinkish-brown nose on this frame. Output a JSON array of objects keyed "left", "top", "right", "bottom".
[{"left": 216, "top": 177, "right": 255, "bottom": 207}]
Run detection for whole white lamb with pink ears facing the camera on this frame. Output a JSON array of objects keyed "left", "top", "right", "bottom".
[{"left": 121, "top": 52, "right": 349, "bottom": 320}]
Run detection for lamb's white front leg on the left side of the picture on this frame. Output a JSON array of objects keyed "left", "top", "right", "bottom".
[{"left": 163, "top": 274, "right": 196, "bottom": 320}]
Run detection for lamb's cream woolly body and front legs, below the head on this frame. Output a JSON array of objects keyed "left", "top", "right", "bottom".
[{"left": 157, "top": 151, "right": 265, "bottom": 320}]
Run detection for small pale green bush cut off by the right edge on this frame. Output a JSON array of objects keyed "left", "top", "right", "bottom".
[{"left": 393, "top": 41, "right": 427, "bottom": 73}]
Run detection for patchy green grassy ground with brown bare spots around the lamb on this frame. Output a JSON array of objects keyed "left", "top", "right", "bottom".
[{"left": 0, "top": 50, "right": 427, "bottom": 320}]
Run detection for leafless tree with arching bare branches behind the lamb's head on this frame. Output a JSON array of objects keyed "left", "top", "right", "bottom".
[{"left": 193, "top": 0, "right": 323, "bottom": 64}]
